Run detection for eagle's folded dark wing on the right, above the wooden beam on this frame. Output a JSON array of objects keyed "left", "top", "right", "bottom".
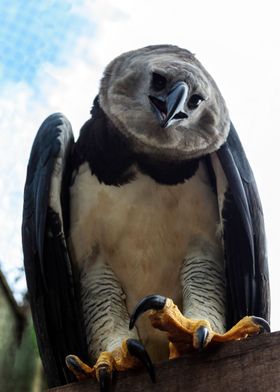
[{"left": 217, "top": 124, "right": 270, "bottom": 327}]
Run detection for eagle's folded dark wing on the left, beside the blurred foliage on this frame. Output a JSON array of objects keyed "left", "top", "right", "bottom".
[{"left": 22, "top": 114, "right": 86, "bottom": 386}]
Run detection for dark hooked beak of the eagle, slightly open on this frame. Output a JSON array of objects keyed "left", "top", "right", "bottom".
[{"left": 149, "top": 81, "right": 189, "bottom": 128}]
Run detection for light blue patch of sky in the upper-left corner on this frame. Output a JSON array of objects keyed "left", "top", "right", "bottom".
[{"left": 0, "top": 0, "right": 94, "bottom": 83}]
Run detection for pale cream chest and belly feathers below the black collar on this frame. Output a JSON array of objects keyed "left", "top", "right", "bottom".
[{"left": 69, "top": 163, "right": 219, "bottom": 307}]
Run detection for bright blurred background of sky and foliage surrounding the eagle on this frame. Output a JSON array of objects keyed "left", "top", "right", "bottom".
[{"left": 0, "top": 0, "right": 280, "bottom": 391}]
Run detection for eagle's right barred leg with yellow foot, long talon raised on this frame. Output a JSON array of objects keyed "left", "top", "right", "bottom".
[{"left": 130, "top": 243, "right": 269, "bottom": 358}]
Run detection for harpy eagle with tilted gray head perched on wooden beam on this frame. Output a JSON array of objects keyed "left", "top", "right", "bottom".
[{"left": 22, "top": 45, "right": 270, "bottom": 391}]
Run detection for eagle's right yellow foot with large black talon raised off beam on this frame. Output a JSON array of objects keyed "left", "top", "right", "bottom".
[{"left": 129, "top": 295, "right": 270, "bottom": 359}]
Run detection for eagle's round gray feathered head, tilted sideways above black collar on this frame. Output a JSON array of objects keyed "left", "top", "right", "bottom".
[{"left": 99, "top": 45, "right": 230, "bottom": 160}]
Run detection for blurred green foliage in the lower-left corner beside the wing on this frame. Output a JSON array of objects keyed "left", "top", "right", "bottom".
[{"left": 0, "top": 276, "right": 44, "bottom": 392}]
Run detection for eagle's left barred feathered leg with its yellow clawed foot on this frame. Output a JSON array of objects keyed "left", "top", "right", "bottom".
[{"left": 66, "top": 258, "right": 154, "bottom": 392}]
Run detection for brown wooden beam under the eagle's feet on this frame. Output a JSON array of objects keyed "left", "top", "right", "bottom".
[{"left": 50, "top": 332, "right": 280, "bottom": 392}]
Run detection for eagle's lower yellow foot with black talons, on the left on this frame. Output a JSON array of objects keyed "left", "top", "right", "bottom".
[{"left": 65, "top": 339, "right": 155, "bottom": 392}]
